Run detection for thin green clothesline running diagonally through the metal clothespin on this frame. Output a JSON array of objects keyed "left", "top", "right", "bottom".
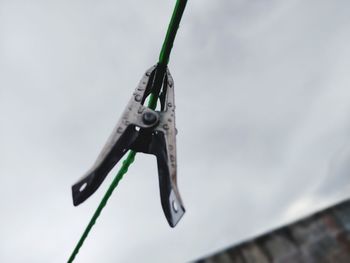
[{"left": 68, "top": 0, "right": 187, "bottom": 263}]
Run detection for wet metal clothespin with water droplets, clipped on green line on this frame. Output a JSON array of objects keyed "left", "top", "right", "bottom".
[{"left": 72, "top": 64, "right": 185, "bottom": 227}]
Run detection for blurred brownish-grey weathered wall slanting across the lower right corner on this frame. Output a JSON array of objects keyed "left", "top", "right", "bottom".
[{"left": 194, "top": 200, "right": 350, "bottom": 263}]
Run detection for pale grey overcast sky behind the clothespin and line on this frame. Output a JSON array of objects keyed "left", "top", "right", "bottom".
[{"left": 0, "top": 0, "right": 350, "bottom": 263}]
